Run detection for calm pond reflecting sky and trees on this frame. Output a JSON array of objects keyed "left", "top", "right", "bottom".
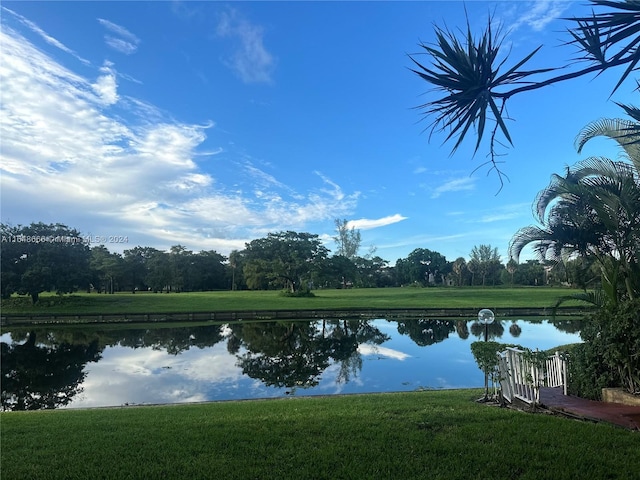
[{"left": 0, "top": 318, "right": 580, "bottom": 410}]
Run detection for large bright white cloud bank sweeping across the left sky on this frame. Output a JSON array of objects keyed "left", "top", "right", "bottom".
[{"left": 0, "top": 22, "right": 358, "bottom": 254}]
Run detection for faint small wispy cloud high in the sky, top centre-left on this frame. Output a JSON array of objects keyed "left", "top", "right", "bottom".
[{"left": 216, "top": 10, "right": 276, "bottom": 83}]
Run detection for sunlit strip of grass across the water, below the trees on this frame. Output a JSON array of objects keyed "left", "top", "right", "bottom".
[{"left": 2, "top": 287, "right": 580, "bottom": 315}]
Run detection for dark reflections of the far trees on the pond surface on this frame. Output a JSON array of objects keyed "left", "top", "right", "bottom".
[{"left": 0, "top": 317, "right": 581, "bottom": 410}]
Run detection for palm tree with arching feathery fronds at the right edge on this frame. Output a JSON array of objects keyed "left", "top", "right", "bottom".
[{"left": 509, "top": 119, "right": 640, "bottom": 304}]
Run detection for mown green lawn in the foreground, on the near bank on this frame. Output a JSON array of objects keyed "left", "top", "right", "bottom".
[{"left": 0, "top": 390, "right": 640, "bottom": 480}]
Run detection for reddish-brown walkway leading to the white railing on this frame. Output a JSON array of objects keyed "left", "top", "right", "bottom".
[{"left": 540, "top": 387, "right": 640, "bottom": 431}]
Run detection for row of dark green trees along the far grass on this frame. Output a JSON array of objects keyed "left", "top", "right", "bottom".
[{"left": 1, "top": 220, "right": 589, "bottom": 302}]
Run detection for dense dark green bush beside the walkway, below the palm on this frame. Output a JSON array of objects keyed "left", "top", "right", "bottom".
[{"left": 569, "top": 300, "right": 640, "bottom": 399}]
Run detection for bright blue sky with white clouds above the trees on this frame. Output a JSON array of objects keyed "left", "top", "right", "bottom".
[{"left": 0, "top": 0, "right": 633, "bottom": 265}]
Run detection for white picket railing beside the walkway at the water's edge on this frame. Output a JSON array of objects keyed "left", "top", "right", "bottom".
[{"left": 498, "top": 348, "right": 567, "bottom": 404}]
